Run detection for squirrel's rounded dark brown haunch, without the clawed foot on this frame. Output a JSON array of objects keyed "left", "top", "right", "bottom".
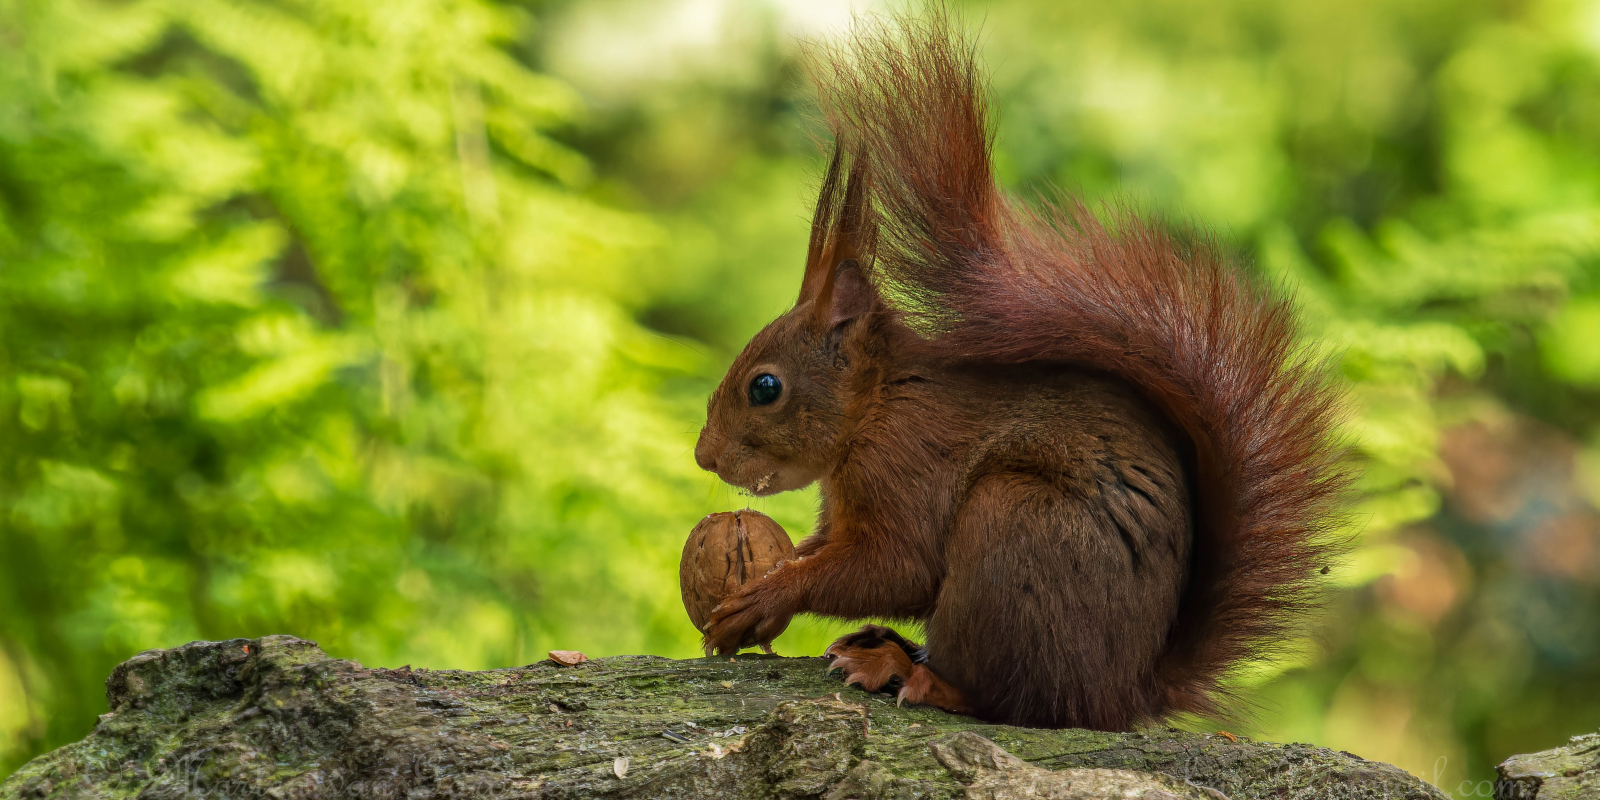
[{"left": 926, "top": 462, "right": 1187, "bottom": 730}]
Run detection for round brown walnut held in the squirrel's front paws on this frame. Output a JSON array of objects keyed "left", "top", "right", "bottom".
[{"left": 678, "top": 509, "right": 795, "bottom": 634}]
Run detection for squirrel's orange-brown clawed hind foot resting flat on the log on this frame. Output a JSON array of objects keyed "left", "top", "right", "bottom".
[{"left": 824, "top": 626, "right": 973, "bottom": 714}]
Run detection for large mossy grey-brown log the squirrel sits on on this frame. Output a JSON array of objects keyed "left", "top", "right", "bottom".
[{"left": 0, "top": 637, "right": 1445, "bottom": 800}]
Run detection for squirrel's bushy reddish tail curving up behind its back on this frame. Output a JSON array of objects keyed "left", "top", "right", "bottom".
[{"left": 814, "top": 11, "right": 1346, "bottom": 715}]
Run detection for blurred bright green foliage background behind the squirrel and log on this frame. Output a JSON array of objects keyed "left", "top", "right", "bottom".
[{"left": 0, "top": 0, "right": 1600, "bottom": 795}]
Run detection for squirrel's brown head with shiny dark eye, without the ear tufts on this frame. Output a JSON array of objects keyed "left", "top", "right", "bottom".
[{"left": 694, "top": 261, "right": 872, "bottom": 496}]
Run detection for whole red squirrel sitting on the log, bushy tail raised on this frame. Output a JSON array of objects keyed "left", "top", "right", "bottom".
[{"left": 694, "top": 13, "right": 1347, "bottom": 730}]
